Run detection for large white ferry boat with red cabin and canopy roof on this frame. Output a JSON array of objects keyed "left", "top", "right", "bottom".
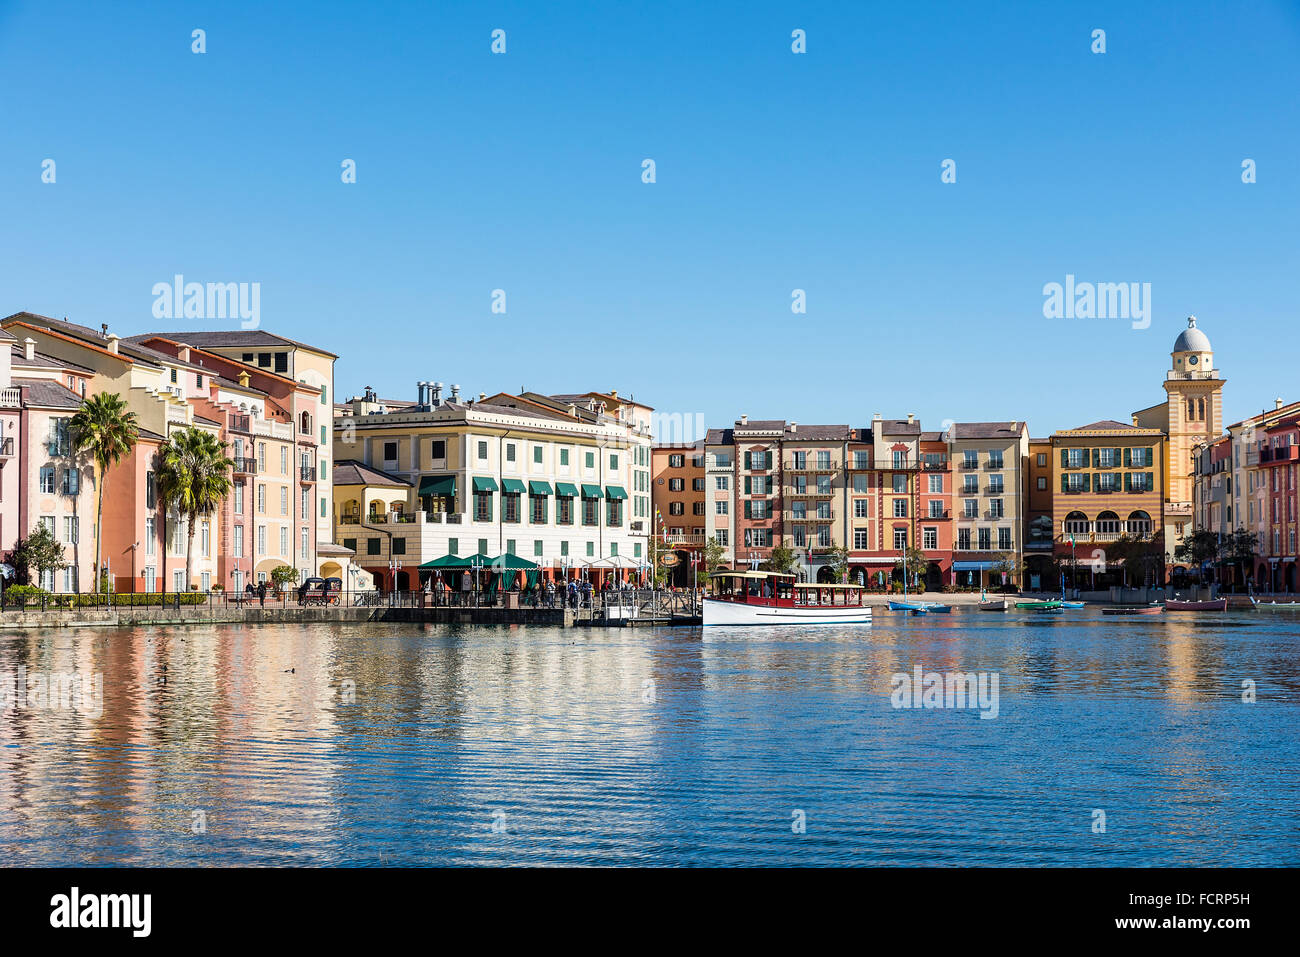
[{"left": 703, "top": 572, "right": 871, "bottom": 627}]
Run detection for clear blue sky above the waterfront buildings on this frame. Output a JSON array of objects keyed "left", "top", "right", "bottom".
[{"left": 0, "top": 0, "right": 1300, "bottom": 434}]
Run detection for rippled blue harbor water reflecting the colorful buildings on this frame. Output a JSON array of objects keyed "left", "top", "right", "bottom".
[{"left": 0, "top": 610, "right": 1300, "bottom": 866}]
